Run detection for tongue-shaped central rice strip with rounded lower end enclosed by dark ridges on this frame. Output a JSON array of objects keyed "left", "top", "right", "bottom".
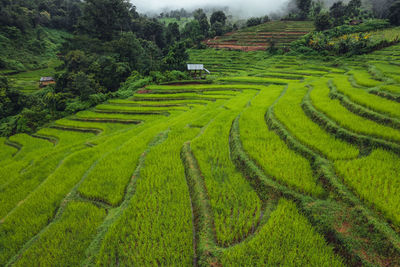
[{"left": 191, "top": 92, "right": 261, "bottom": 246}]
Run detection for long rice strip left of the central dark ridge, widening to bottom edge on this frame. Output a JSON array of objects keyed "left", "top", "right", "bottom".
[{"left": 97, "top": 106, "right": 217, "bottom": 266}]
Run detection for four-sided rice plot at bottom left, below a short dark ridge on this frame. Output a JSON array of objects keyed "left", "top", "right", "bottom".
[{"left": 15, "top": 202, "right": 106, "bottom": 266}]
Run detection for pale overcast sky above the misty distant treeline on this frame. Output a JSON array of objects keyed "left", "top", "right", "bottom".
[{"left": 131, "top": 0, "right": 287, "bottom": 17}]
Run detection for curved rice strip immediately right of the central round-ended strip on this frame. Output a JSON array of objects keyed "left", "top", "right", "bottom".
[{"left": 239, "top": 86, "right": 324, "bottom": 196}]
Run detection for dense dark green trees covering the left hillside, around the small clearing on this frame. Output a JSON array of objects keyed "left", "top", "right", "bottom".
[{"left": 0, "top": 0, "right": 191, "bottom": 135}]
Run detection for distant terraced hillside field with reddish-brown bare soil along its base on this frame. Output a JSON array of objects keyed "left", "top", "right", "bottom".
[{"left": 204, "top": 21, "right": 314, "bottom": 51}]
